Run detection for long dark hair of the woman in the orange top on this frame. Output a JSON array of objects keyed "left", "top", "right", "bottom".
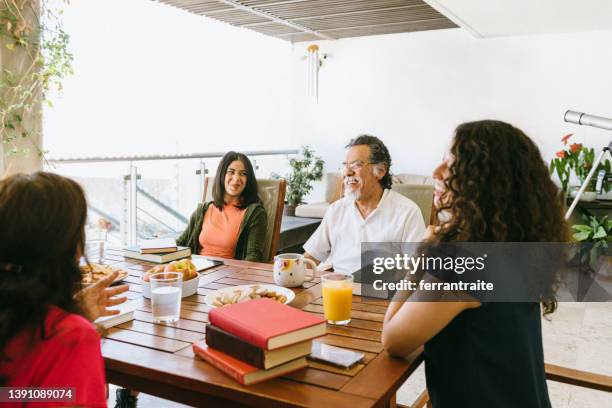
[{"left": 213, "top": 151, "right": 261, "bottom": 210}]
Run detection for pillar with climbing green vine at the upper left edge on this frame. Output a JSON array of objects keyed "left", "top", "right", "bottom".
[{"left": 0, "top": 0, "right": 73, "bottom": 159}]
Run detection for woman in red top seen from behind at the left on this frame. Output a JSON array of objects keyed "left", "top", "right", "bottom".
[{"left": 0, "top": 172, "right": 106, "bottom": 407}]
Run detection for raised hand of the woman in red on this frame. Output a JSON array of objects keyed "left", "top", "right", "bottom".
[{"left": 76, "top": 271, "right": 129, "bottom": 322}]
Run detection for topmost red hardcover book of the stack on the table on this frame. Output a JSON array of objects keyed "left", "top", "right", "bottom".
[{"left": 208, "top": 299, "right": 325, "bottom": 350}]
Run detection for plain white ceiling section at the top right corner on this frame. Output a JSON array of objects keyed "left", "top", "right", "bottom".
[{"left": 424, "top": 0, "right": 612, "bottom": 37}]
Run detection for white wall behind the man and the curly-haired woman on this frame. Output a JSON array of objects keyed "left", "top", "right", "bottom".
[{"left": 292, "top": 29, "right": 612, "bottom": 201}]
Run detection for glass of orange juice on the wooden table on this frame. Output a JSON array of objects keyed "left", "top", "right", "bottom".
[{"left": 321, "top": 273, "right": 353, "bottom": 325}]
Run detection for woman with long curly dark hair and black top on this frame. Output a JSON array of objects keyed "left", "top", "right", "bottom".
[{"left": 382, "top": 121, "right": 568, "bottom": 408}]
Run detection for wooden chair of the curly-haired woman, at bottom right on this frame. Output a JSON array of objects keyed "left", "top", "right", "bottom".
[{"left": 406, "top": 364, "right": 612, "bottom": 408}]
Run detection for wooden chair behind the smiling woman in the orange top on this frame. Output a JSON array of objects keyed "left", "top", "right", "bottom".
[{"left": 203, "top": 177, "right": 287, "bottom": 262}]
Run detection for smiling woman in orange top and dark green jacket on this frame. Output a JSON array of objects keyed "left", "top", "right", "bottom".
[{"left": 177, "top": 152, "right": 268, "bottom": 262}]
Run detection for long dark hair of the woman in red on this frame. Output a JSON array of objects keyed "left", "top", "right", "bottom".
[{"left": 0, "top": 172, "right": 87, "bottom": 366}]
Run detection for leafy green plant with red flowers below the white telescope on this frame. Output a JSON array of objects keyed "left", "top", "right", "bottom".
[{"left": 550, "top": 133, "right": 612, "bottom": 192}]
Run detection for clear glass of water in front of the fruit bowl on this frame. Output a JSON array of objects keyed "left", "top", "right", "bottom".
[{"left": 149, "top": 272, "right": 183, "bottom": 323}]
